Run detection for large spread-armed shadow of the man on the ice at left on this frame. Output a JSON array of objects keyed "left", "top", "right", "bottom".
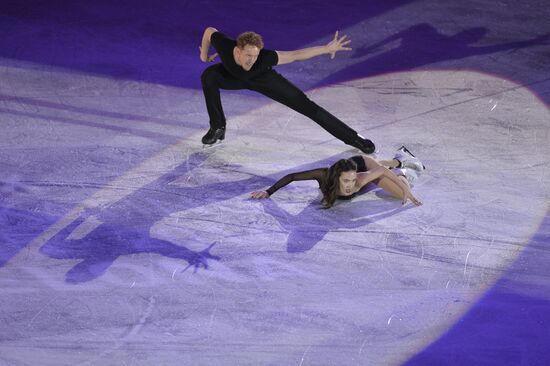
[{"left": 36, "top": 152, "right": 342, "bottom": 283}]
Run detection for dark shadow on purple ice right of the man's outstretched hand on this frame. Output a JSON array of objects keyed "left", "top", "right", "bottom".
[{"left": 319, "top": 23, "right": 550, "bottom": 85}]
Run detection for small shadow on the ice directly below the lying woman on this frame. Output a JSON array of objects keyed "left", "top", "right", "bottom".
[{"left": 261, "top": 194, "right": 413, "bottom": 253}]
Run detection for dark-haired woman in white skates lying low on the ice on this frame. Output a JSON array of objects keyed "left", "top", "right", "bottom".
[{"left": 250, "top": 146, "right": 425, "bottom": 208}]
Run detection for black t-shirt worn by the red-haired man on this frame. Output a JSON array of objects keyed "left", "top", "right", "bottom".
[{"left": 210, "top": 32, "right": 279, "bottom": 81}]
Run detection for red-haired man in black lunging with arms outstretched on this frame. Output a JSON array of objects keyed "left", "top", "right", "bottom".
[{"left": 199, "top": 27, "right": 375, "bottom": 154}]
